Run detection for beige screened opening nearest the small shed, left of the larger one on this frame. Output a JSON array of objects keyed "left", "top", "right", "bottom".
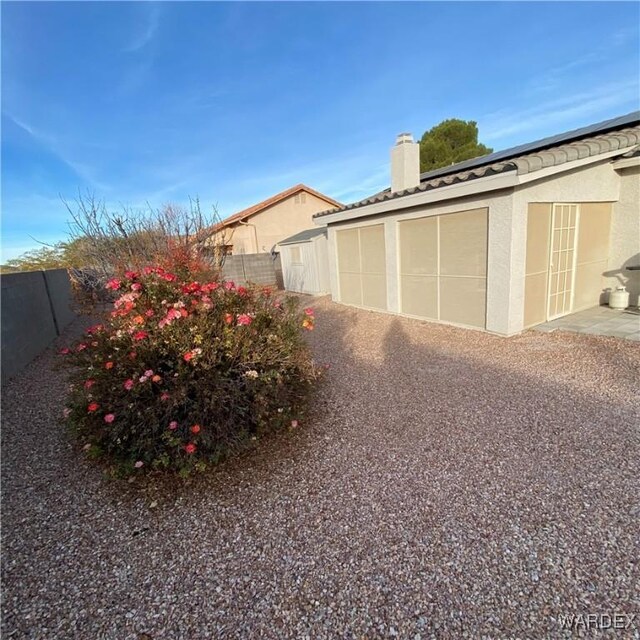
[{"left": 336, "top": 224, "right": 387, "bottom": 309}]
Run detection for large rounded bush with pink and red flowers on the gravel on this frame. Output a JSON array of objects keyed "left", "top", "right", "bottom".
[{"left": 63, "top": 267, "right": 319, "bottom": 473}]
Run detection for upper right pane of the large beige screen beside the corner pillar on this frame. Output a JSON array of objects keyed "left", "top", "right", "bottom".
[{"left": 440, "top": 209, "right": 487, "bottom": 276}]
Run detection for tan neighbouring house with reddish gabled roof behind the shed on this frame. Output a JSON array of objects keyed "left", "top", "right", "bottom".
[{"left": 209, "top": 184, "right": 342, "bottom": 255}]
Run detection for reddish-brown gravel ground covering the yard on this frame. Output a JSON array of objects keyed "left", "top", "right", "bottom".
[{"left": 2, "top": 299, "right": 640, "bottom": 640}]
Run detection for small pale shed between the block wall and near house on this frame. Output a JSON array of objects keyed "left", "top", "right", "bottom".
[{"left": 278, "top": 227, "right": 331, "bottom": 295}]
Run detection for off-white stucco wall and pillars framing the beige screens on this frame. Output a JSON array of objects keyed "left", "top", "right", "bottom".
[{"left": 328, "top": 158, "right": 640, "bottom": 336}]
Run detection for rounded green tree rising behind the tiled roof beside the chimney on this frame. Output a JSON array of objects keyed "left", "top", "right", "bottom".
[{"left": 420, "top": 118, "right": 493, "bottom": 173}]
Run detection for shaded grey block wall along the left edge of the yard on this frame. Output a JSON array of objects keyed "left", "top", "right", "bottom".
[{"left": 0, "top": 269, "right": 75, "bottom": 382}]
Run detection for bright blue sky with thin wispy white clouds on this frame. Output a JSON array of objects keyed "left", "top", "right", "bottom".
[{"left": 2, "top": 2, "right": 640, "bottom": 259}]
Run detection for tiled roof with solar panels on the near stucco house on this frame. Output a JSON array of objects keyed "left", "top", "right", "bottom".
[{"left": 313, "top": 112, "right": 640, "bottom": 218}]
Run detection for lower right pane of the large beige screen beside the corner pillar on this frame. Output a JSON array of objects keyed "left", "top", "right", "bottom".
[{"left": 440, "top": 277, "right": 487, "bottom": 328}]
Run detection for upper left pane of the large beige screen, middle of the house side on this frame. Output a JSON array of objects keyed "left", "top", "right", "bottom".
[{"left": 399, "top": 217, "right": 438, "bottom": 275}]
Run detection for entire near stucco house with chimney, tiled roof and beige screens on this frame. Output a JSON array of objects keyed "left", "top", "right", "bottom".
[{"left": 314, "top": 112, "right": 640, "bottom": 335}]
